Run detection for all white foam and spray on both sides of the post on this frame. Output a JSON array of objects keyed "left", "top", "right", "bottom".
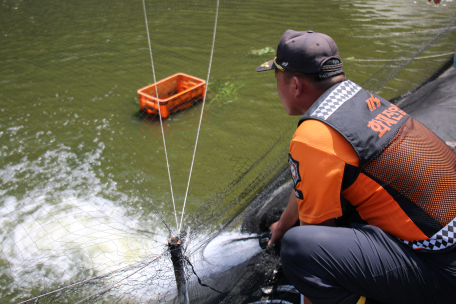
[{"left": 0, "top": 137, "right": 261, "bottom": 303}]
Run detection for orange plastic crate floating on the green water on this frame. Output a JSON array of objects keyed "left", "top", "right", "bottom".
[{"left": 138, "top": 73, "right": 206, "bottom": 118}]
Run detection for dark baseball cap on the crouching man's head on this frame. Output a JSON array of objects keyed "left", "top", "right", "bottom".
[{"left": 256, "top": 30, "right": 342, "bottom": 74}]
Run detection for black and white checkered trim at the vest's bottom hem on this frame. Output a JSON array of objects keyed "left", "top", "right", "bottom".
[{"left": 399, "top": 218, "right": 456, "bottom": 250}]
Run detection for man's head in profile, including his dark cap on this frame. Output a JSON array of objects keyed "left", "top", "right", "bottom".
[{"left": 256, "top": 30, "right": 345, "bottom": 115}]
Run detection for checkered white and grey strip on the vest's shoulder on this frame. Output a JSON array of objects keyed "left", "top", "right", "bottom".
[{"left": 310, "top": 80, "right": 361, "bottom": 120}]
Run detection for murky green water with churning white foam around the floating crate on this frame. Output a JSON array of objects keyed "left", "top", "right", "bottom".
[{"left": 0, "top": 0, "right": 456, "bottom": 304}]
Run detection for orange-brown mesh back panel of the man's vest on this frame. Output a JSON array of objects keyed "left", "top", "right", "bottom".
[{"left": 362, "top": 119, "right": 456, "bottom": 228}]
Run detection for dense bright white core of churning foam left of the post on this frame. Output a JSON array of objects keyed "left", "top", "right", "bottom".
[{"left": 0, "top": 196, "right": 165, "bottom": 287}]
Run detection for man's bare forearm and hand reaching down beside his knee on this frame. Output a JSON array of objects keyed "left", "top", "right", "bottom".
[{"left": 268, "top": 189, "right": 336, "bottom": 246}]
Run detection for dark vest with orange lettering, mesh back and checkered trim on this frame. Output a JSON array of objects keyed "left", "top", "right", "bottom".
[{"left": 299, "top": 80, "right": 456, "bottom": 250}]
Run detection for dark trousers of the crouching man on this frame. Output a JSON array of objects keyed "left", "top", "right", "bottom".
[{"left": 281, "top": 224, "right": 456, "bottom": 304}]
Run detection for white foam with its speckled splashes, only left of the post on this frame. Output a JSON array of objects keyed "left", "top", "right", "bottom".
[{"left": 0, "top": 142, "right": 173, "bottom": 296}]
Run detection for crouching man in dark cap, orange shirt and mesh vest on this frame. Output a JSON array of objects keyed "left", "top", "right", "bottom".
[{"left": 257, "top": 30, "right": 456, "bottom": 304}]
